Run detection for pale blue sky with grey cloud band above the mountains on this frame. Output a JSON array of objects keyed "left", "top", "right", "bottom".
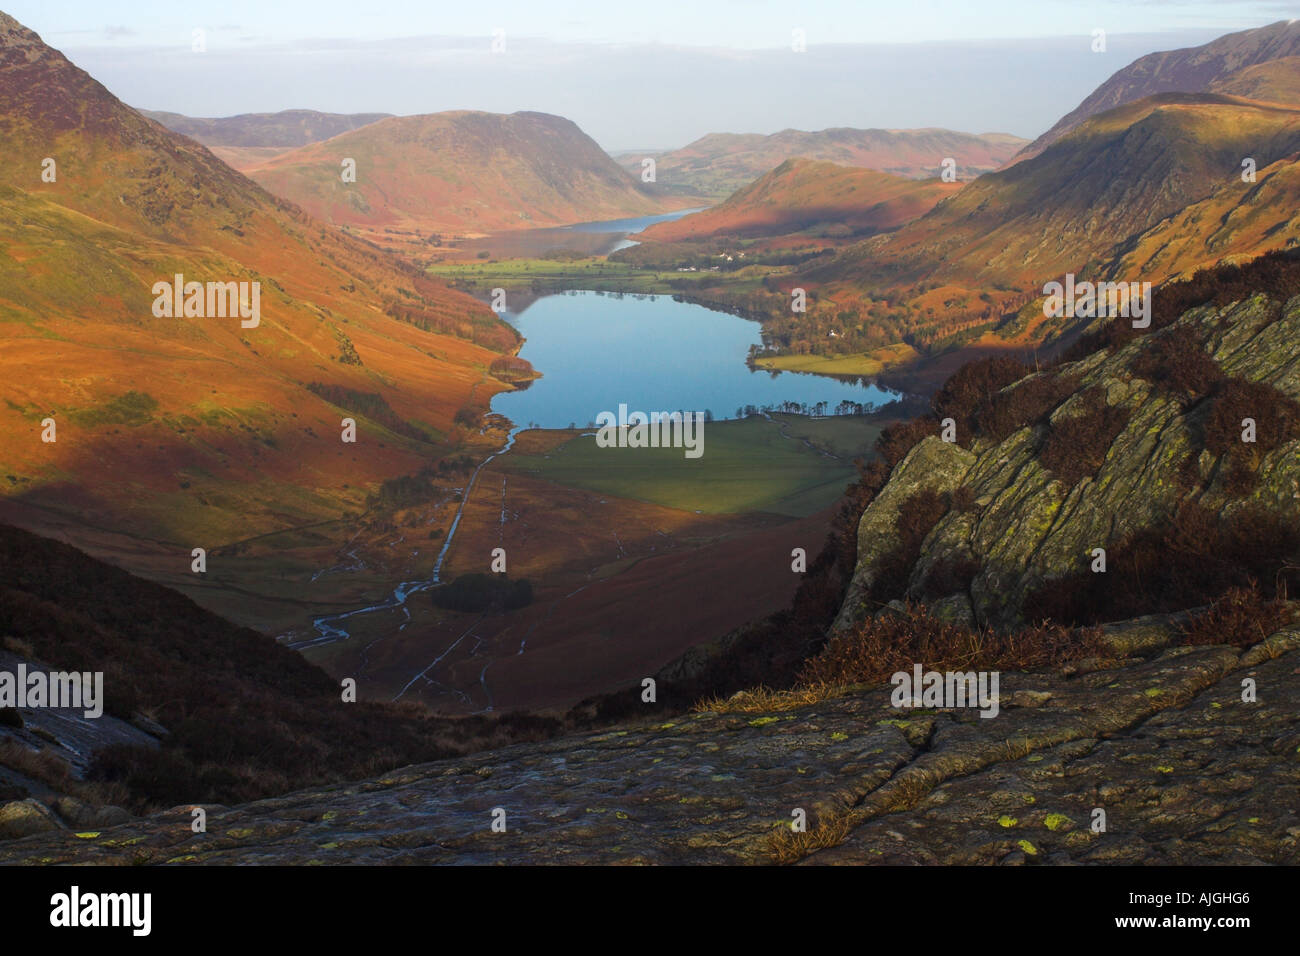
[{"left": 3, "top": 0, "right": 1300, "bottom": 151}]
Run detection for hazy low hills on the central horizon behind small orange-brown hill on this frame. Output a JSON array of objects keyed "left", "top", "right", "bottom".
[{"left": 619, "top": 127, "right": 1024, "bottom": 199}]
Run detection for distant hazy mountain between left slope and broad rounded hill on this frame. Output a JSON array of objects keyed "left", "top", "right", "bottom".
[{"left": 139, "top": 109, "right": 393, "bottom": 172}]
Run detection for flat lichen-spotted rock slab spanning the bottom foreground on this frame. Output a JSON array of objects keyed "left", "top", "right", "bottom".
[{"left": 0, "top": 618, "right": 1300, "bottom": 865}]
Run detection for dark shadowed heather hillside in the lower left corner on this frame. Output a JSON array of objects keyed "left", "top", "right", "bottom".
[{"left": 0, "top": 524, "right": 558, "bottom": 816}]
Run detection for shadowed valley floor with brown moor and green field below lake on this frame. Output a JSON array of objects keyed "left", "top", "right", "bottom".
[{"left": 0, "top": 415, "right": 889, "bottom": 714}]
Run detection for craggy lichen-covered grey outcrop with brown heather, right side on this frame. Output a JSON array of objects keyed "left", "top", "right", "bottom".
[{"left": 836, "top": 295, "right": 1300, "bottom": 630}]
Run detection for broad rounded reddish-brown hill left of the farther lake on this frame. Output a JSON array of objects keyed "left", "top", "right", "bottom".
[{"left": 247, "top": 111, "right": 683, "bottom": 233}]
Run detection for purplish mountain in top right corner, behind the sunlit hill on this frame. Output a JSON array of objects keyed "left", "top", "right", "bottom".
[{"left": 1015, "top": 20, "right": 1300, "bottom": 161}]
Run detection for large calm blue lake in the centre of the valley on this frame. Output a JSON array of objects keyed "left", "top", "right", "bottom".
[{"left": 491, "top": 291, "right": 896, "bottom": 428}]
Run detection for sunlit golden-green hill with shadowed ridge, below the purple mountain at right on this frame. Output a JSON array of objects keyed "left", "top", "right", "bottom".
[{"left": 811, "top": 94, "right": 1300, "bottom": 295}]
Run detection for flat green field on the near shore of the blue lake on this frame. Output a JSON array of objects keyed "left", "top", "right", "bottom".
[{"left": 501, "top": 416, "right": 879, "bottom": 518}]
